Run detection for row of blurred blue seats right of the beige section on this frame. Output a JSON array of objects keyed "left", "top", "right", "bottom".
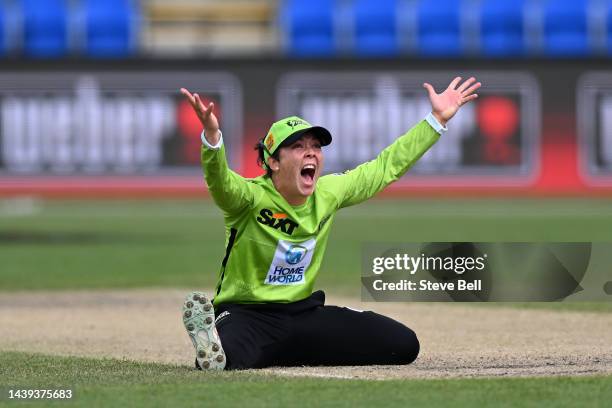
[{"left": 282, "top": 0, "right": 612, "bottom": 58}]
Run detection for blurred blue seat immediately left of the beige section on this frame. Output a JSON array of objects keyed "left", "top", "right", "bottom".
[{"left": 83, "top": 0, "right": 138, "bottom": 58}]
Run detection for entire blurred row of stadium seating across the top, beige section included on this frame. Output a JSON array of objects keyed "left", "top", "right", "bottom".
[{"left": 0, "top": 0, "right": 612, "bottom": 58}]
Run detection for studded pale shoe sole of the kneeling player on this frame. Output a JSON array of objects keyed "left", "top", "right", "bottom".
[{"left": 183, "top": 292, "right": 226, "bottom": 370}]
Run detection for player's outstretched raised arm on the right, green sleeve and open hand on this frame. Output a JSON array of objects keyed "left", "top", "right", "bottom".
[{"left": 319, "top": 77, "right": 481, "bottom": 208}]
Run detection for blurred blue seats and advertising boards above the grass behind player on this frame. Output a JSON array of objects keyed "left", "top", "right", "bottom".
[{"left": 0, "top": 0, "right": 612, "bottom": 196}]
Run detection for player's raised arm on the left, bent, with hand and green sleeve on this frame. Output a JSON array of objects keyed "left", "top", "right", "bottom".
[{"left": 181, "top": 88, "right": 256, "bottom": 216}]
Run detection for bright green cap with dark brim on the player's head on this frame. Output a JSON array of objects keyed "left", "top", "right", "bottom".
[{"left": 263, "top": 116, "right": 331, "bottom": 165}]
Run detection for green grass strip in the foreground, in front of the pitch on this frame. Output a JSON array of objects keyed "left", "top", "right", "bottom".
[{"left": 0, "top": 353, "right": 612, "bottom": 407}]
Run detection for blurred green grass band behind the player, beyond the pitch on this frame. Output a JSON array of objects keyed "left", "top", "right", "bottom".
[{"left": 0, "top": 199, "right": 612, "bottom": 296}]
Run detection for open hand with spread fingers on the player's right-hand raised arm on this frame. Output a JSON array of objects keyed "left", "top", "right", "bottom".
[{"left": 423, "top": 77, "right": 481, "bottom": 126}]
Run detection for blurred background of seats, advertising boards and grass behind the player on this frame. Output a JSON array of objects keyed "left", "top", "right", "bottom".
[{"left": 0, "top": 0, "right": 612, "bottom": 300}]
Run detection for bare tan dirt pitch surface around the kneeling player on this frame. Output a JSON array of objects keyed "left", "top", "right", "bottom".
[{"left": 0, "top": 290, "right": 612, "bottom": 379}]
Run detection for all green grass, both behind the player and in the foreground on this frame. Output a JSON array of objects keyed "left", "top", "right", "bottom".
[{"left": 0, "top": 199, "right": 612, "bottom": 407}]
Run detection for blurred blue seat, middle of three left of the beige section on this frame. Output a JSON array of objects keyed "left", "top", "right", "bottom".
[{"left": 20, "top": 0, "right": 68, "bottom": 58}]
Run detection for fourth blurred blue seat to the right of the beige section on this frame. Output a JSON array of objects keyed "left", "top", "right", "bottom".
[{"left": 480, "top": 0, "right": 526, "bottom": 57}]
